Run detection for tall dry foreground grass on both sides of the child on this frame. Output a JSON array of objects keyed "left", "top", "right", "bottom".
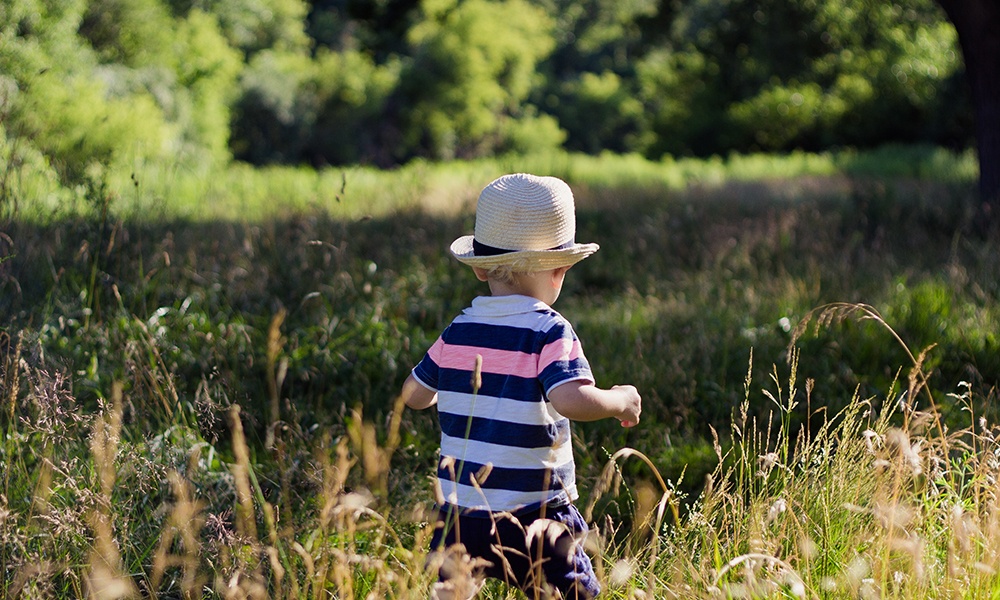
[{"left": 0, "top": 305, "right": 1000, "bottom": 599}]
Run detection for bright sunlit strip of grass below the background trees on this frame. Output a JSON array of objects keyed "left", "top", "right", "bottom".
[{"left": 7, "top": 147, "right": 978, "bottom": 223}]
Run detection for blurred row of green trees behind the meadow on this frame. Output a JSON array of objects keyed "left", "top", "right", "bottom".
[{"left": 0, "top": 0, "right": 974, "bottom": 182}]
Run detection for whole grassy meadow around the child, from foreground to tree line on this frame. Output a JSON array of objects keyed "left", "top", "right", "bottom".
[{"left": 0, "top": 147, "right": 1000, "bottom": 598}]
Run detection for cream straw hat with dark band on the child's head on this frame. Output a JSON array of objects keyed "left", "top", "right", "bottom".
[{"left": 451, "top": 173, "right": 599, "bottom": 272}]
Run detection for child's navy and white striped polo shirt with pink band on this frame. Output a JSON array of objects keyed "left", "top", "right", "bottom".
[{"left": 413, "top": 295, "right": 594, "bottom": 514}]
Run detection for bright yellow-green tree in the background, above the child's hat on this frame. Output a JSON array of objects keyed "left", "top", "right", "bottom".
[{"left": 401, "top": 0, "right": 553, "bottom": 159}]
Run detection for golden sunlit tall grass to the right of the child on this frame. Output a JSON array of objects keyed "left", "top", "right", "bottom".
[{"left": 584, "top": 304, "right": 1000, "bottom": 598}]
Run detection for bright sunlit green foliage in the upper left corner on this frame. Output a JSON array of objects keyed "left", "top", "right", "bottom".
[{"left": 0, "top": 0, "right": 240, "bottom": 186}]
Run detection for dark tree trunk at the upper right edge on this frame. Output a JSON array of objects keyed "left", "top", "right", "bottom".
[{"left": 938, "top": 0, "right": 1000, "bottom": 231}]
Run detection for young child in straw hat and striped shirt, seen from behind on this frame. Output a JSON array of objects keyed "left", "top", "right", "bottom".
[{"left": 402, "top": 173, "right": 641, "bottom": 598}]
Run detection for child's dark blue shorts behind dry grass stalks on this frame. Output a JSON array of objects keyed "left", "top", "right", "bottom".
[{"left": 431, "top": 504, "right": 601, "bottom": 600}]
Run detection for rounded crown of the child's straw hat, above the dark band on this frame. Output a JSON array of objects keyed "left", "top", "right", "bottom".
[{"left": 475, "top": 173, "right": 576, "bottom": 251}]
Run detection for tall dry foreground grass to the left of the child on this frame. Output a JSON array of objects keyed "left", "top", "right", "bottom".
[{"left": 0, "top": 326, "right": 438, "bottom": 599}]
